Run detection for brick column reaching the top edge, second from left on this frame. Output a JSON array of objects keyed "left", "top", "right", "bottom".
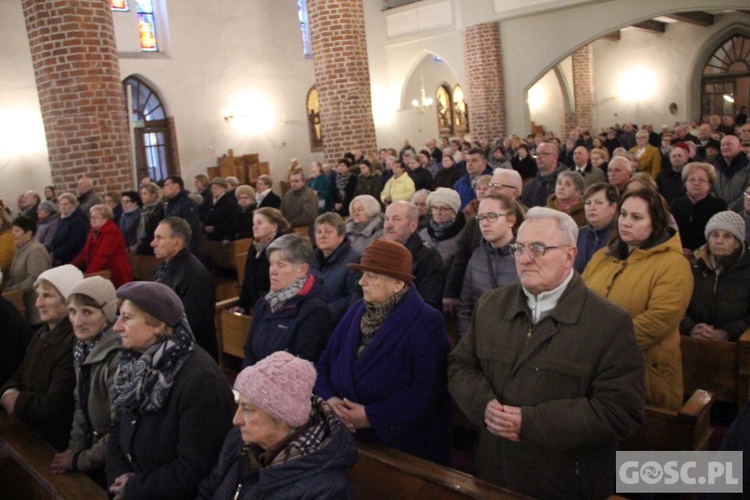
[{"left": 307, "top": 0, "right": 377, "bottom": 162}]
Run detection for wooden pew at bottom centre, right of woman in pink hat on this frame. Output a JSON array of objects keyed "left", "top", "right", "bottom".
[{"left": 349, "top": 443, "right": 526, "bottom": 500}]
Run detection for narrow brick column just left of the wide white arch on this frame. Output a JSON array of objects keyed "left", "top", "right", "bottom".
[{"left": 464, "top": 23, "right": 508, "bottom": 142}]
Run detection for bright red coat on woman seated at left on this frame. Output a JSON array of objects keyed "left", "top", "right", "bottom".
[{"left": 71, "top": 220, "right": 133, "bottom": 288}]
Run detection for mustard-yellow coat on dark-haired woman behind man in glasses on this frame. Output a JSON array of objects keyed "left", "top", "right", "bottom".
[{"left": 583, "top": 234, "right": 693, "bottom": 409}]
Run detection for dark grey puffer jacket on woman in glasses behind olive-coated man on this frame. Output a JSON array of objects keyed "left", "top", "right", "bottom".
[{"left": 458, "top": 238, "right": 518, "bottom": 337}]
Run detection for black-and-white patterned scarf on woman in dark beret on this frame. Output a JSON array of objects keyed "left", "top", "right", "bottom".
[{"left": 113, "top": 316, "right": 195, "bottom": 413}]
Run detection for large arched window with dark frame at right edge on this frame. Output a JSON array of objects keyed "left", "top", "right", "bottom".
[{"left": 701, "top": 35, "right": 750, "bottom": 116}]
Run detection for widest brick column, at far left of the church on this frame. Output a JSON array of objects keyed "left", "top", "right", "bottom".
[{"left": 22, "top": 0, "right": 133, "bottom": 191}]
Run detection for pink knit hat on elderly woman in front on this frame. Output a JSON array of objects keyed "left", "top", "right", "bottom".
[{"left": 234, "top": 351, "right": 316, "bottom": 427}]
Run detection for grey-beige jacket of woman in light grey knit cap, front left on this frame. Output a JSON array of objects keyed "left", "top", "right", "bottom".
[{"left": 69, "top": 326, "right": 122, "bottom": 472}]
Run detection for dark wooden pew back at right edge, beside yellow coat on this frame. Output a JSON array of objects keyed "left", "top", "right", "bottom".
[{"left": 680, "top": 330, "right": 750, "bottom": 410}]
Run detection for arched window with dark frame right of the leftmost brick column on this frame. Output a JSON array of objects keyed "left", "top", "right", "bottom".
[{"left": 122, "top": 76, "right": 177, "bottom": 181}]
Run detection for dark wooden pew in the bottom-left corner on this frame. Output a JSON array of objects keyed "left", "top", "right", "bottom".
[{"left": 0, "top": 412, "right": 108, "bottom": 500}]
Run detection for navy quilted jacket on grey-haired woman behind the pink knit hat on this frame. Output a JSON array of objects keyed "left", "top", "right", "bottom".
[{"left": 242, "top": 275, "right": 333, "bottom": 368}]
